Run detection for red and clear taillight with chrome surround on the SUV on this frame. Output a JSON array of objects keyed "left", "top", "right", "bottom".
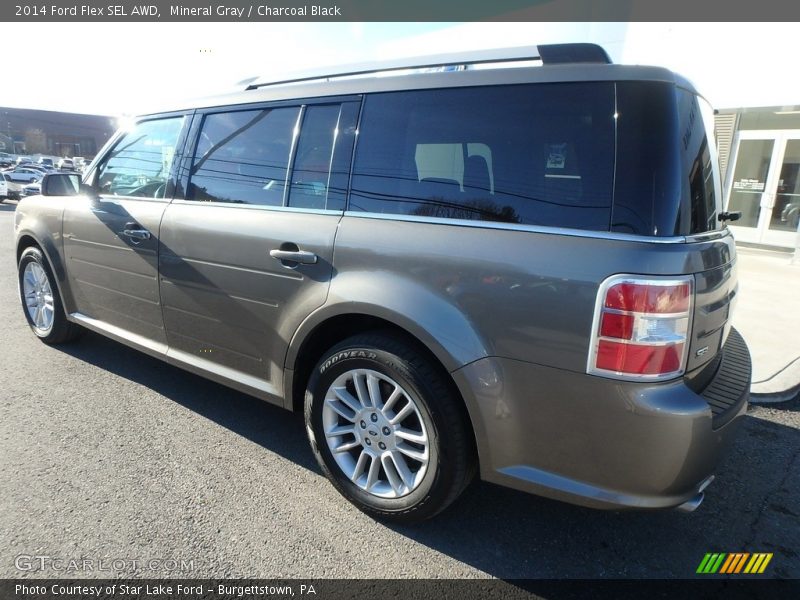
[{"left": 587, "top": 275, "right": 694, "bottom": 381}]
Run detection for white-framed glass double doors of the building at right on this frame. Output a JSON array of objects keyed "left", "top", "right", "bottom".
[{"left": 727, "top": 131, "right": 800, "bottom": 247}]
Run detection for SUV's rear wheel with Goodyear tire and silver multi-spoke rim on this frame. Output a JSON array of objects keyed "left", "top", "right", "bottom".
[{"left": 305, "top": 332, "right": 476, "bottom": 523}]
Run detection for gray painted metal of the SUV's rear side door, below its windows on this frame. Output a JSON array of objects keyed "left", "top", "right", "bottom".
[{"left": 160, "top": 202, "right": 341, "bottom": 403}]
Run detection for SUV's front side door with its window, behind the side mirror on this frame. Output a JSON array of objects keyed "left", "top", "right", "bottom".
[{"left": 63, "top": 114, "right": 188, "bottom": 351}]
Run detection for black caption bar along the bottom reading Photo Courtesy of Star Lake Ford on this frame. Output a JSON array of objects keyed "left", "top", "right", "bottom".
[{"left": 0, "top": 576, "right": 800, "bottom": 600}]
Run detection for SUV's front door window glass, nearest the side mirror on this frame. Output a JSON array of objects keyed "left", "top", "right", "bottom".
[{"left": 95, "top": 117, "right": 183, "bottom": 198}]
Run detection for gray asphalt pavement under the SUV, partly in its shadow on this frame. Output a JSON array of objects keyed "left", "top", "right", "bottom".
[{"left": 0, "top": 204, "right": 800, "bottom": 578}]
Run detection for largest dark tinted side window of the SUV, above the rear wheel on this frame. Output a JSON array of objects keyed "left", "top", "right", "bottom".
[{"left": 349, "top": 83, "right": 614, "bottom": 231}]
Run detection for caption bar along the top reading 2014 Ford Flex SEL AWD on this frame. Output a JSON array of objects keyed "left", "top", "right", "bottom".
[{"left": 0, "top": 0, "right": 800, "bottom": 23}]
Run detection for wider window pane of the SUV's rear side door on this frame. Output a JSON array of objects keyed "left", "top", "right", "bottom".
[{"left": 187, "top": 107, "right": 300, "bottom": 206}]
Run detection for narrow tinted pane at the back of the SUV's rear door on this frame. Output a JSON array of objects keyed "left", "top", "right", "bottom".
[{"left": 289, "top": 104, "right": 339, "bottom": 209}]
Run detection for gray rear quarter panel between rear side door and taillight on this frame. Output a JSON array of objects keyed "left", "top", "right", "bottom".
[{"left": 328, "top": 213, "right": 734, "bottom": 373}]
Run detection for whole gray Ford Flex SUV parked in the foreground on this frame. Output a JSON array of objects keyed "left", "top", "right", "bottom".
[{"left": 15, "top": 45, "right": 750, "bottom": 521}]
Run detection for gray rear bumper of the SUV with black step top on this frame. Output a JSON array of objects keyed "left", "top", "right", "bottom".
[{"left": 454, "top": 330, "right": 750, "bottom": 509}]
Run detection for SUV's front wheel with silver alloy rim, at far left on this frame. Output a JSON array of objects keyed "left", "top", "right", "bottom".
[{"left": 17, "top": 247, "right": 84, "bottom": 344}]
